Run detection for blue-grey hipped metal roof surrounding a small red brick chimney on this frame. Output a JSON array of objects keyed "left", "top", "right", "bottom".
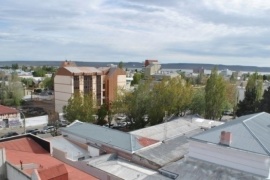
[{"left": 190, "top": 112, "right": 270, "bottom": 156}]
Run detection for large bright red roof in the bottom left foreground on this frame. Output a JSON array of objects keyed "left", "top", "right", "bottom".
[{"left": 0, "top": 137, "right": 97, "bottom": 180}]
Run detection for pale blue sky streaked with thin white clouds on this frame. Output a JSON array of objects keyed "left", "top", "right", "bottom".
[{"left": 0, "top": 0, "right": 270, "bottom": 67}]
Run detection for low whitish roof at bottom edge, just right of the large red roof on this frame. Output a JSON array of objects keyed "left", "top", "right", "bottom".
[{"left": 88, "top": 154, "right": 169, "bottom": 180}]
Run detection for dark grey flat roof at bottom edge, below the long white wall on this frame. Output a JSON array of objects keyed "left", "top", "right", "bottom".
[{"left": 159, "top": 158, "right": 265, "bottom": 180}]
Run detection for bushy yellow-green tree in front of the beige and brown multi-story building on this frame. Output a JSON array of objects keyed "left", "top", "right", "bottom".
[{"left": 63, "top": 92, "right": 96, "bottom": 123}]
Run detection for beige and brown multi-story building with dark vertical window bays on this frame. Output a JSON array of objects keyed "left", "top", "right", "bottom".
[{"left": 54, "top": 63, "right": 126, "bottom": 112}]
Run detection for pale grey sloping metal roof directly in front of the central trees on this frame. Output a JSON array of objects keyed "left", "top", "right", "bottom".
[{"left": 130, "top": 119, "right": 200, "bottom": 141}]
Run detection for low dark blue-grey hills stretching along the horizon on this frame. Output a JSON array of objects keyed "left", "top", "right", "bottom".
[{"left": 0, "top": 60, "right": 270, "bottom": 72}]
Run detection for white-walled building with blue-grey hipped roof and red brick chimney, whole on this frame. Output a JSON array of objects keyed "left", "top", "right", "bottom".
[{"left": 189, "top": 112, "right": 270, "bottom": 178}]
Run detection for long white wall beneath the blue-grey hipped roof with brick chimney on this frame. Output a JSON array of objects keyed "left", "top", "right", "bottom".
[{"left": 188, "top": 141, "right": 270, "bottom": 177}]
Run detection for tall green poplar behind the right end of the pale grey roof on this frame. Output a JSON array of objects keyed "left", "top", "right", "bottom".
[{"left": 205, "top": 68, "right": 226, "bottom": 119}]
